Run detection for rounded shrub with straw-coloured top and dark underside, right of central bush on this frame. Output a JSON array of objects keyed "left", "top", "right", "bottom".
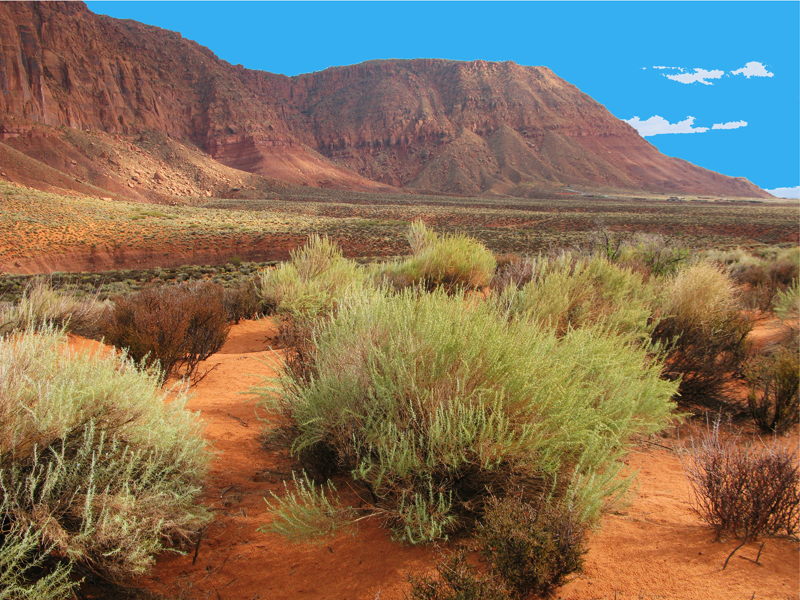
[{"left": 653, "top": 263, "right": 752, "bottom": 403}]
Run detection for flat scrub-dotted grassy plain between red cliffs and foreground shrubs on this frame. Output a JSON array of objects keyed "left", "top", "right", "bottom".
[{"left": 0, "top": 182, "right": 800, "bottom": 273}]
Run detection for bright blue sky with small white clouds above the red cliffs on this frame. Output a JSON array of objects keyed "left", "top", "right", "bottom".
[{"left": 87, "top": 2, "right": 800, "bottom": 196}]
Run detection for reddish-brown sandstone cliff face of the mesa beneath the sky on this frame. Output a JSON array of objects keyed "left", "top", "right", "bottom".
[{"left": 0, "top": 2, "right": 776, "bottom": 196}]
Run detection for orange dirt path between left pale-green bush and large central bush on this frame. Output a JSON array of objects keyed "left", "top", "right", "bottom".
[{"left": 135, "top": 321, "right": 436, "bottom": 600}]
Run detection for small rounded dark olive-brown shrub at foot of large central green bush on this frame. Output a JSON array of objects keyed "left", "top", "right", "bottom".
[{"left": 476, "top": 497, "right": 587, "bottom": 598}]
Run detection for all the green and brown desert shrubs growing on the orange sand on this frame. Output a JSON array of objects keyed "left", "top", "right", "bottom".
[{"left": 0, "top": 217, "right": 799, "bottom": 600}]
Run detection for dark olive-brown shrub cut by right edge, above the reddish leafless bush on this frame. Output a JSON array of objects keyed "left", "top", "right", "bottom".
[{"left": 746, "top": 346, "right": 800, "bottom": 434}]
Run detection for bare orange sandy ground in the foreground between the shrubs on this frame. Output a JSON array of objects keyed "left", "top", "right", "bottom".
[{"left": 89, "top": 320, "right": 800, "bottom": 600}]
